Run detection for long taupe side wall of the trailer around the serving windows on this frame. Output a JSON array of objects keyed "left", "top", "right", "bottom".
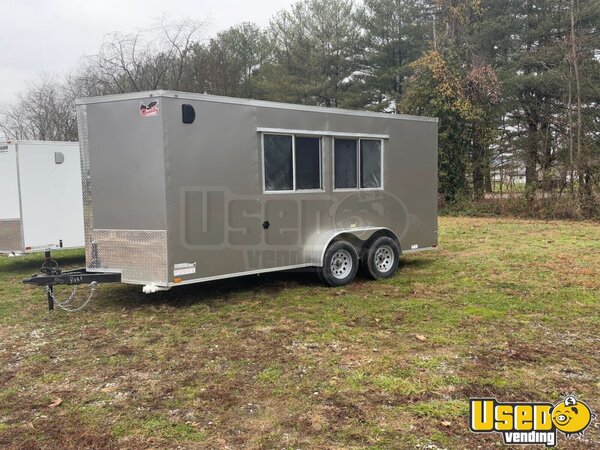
[{"left": 162, "top": 98, "right": 437, "bottom": 282}]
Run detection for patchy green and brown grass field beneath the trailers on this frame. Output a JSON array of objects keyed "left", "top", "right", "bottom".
[{"left": 0, "top": 217, "right": 600, "bottom": 449}]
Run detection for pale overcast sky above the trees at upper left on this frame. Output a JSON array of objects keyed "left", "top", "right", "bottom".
[{"left": 0, "top": 0, "right": 292, "bottom": 104}]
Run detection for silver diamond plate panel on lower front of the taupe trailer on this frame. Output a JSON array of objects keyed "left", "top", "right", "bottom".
[{"left": 87, "top": 230, "right": 169, "bottom": 285}]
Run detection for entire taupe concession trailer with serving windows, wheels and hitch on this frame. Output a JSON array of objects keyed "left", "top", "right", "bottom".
[{"left": 27, "top": 91, "right": 438, "bottom": 308}]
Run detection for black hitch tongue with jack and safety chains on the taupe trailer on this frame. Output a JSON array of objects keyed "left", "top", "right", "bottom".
[{"left": 23, "top": 251, "right": 121, "bottom": 312}]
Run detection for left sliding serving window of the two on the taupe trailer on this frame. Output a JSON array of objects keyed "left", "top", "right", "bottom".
[{"left": 263, "top": 134, "right": 323, "bottom": 192}]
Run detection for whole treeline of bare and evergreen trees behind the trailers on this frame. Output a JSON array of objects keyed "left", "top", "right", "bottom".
[{"left": 0, "top": 0, "right": 600, "bottom": 217}]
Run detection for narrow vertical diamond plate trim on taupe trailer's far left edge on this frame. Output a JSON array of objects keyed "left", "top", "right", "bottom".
[{"left": 77, "top": 105, "right": 97, "bottom": 269}]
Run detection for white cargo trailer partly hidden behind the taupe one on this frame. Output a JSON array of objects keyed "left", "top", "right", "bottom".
[{"left": 0, "top": 141, "right": 84, "bottom": 254}]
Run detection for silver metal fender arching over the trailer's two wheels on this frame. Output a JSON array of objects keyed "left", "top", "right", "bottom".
[{"left": 306, "top": 227, "right": 400, "bottom": 267}]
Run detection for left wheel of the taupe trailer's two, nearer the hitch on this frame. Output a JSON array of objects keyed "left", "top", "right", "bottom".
[{"left": 319, "top": 241, "right": 358, "bottom": 286}]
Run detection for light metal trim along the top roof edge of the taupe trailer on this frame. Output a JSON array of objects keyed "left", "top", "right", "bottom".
[{"left": 75, "top": 90, "right": 438, "bottom": 122}]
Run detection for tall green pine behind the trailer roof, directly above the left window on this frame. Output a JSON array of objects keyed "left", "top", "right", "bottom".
[{"left": 264, "top": 0, "right": 361, "bottom": 106}]
